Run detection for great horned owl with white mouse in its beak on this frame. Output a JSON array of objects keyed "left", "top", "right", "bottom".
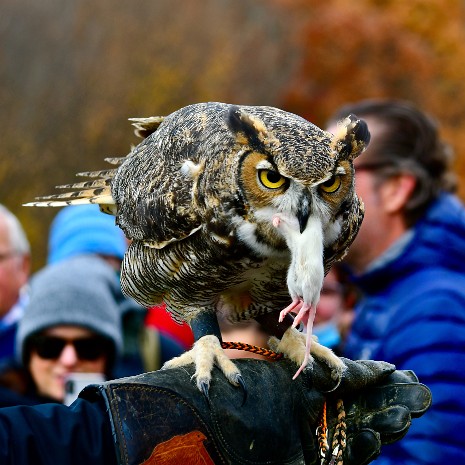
[{"left": 29, "top": 103, "right": 369, "bottom": 392}]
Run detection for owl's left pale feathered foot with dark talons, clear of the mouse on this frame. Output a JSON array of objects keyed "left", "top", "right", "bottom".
[{"left": 162, "top": 335, "right": 247, "bottom": 402}]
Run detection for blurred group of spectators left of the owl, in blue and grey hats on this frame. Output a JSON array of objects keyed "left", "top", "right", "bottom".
[{"left": 0, "top": 205, "right": 193, "bottom": 406}]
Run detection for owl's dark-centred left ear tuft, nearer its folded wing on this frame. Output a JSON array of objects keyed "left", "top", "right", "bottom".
[{"left": 228, "top": 106, "right": 269, "bottom": 151}]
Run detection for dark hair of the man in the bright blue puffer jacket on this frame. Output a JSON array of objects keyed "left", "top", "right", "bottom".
[{"left": 330, "top": 99, "right": 456, "bottom": 226}]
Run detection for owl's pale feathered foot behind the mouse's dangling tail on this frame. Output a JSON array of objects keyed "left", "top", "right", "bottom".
[{"left": 268, "top": 327, "right": 346, "bottom": 389}]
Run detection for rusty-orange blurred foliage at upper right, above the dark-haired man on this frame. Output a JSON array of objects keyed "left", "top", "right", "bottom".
[{"left": 279, "top": 0, "right": 465, "bottom": 198}]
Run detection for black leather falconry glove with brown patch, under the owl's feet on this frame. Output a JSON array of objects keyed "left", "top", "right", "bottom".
[{"left": 80, "top": 359, "right": 431, "bottom": 465}]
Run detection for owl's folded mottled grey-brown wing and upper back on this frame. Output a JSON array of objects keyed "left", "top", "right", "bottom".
[{"left": 111, "top": 104, "right": 239, "bottom": 248}]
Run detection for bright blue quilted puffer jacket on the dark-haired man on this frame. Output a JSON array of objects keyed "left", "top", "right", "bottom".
[{"left": 344, "top": 194, "right": 465, "bottom": 465}]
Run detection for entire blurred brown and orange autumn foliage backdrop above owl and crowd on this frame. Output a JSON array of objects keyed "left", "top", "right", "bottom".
[{"left": 0, "top": 0, "right": 465, "bottom": 268}]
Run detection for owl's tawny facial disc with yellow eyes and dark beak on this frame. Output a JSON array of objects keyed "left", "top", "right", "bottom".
[{"left": 237, "top": 151, "right": 353, "bottom": 256}]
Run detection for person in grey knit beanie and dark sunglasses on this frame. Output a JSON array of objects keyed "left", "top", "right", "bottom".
[{"left": 0, "top": 255, "right": 122, "bottom": 406}]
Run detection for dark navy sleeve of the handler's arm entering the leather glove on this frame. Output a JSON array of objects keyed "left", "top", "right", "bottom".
[{"left": 0, "top": 399, "right": 116, "bottom": 465}]
